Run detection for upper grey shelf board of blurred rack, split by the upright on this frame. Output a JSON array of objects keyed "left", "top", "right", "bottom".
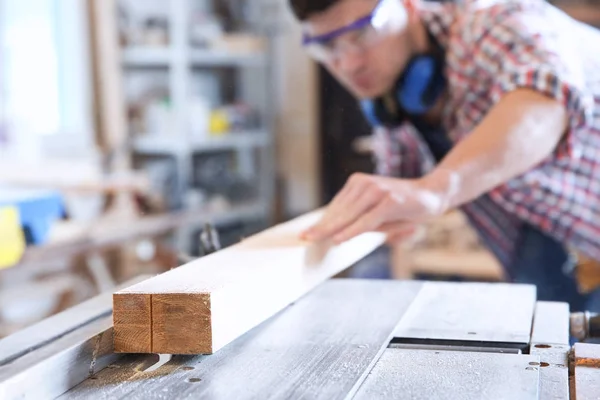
[{"left": 122, "top": 47, "right": 266, "bottom": 67}]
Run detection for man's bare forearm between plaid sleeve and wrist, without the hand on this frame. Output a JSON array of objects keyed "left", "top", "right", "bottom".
[{"left": 423, "top": 89, "right": 568, "bottom": 208}]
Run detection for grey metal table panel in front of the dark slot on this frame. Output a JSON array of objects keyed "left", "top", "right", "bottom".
[{"left": 354, "top": 349, "right": 539, "bottom": 400}]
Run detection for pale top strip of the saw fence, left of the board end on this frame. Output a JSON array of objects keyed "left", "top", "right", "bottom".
[{"left": 0, "top": 275, "right": 150, "bottom": 366}]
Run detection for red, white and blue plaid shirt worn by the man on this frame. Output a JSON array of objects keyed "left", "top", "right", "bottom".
[{"left": 373, "top": 0, "right": 600, "bottom": 276}]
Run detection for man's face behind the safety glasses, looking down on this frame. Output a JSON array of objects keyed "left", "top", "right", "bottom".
[{"left": 305, "top": 0, "right": 410, "bottom": 99}]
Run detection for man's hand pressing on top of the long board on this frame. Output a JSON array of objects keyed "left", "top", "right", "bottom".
[{"left": 302, "top": 174, "right": 453, "bottom": 243}]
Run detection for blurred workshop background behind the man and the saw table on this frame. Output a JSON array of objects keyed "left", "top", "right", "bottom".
[{"left": 0, "top": 0, "right": 600, "bottom": 337}]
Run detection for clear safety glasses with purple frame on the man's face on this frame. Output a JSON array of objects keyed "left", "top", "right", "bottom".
[{"left": 302, "top": 0, "right": 407, "bottom": 63}]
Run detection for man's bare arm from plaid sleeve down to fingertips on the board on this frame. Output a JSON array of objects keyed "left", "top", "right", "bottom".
[{"left": 302, "top": 89, "right": 568, "bottom": 243}]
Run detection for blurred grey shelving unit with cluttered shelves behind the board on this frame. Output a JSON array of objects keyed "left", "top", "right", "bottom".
[{"left": 119, "top": 0, "right": 276, "bottom": 250}]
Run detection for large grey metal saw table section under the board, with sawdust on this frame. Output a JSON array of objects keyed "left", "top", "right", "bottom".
[{"left": 61, "top": 279, "right": 421, "bottom": 400}]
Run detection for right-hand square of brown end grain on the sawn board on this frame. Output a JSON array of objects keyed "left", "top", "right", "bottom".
[{"left": 152, "top": 293, "right": 213, "bottom": 354}]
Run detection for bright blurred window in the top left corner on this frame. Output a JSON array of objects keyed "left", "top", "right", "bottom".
[{"left": 0, "top": 0, "right": 94, "bottom": 159}]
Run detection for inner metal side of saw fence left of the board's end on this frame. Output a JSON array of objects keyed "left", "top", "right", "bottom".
[{"left": 0, "top": 316, "right": 118, "bottom": 400}]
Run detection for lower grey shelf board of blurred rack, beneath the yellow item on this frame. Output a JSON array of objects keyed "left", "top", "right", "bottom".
[{"left": 133, "top": 130, "right": 269, "bottom": 155}]
